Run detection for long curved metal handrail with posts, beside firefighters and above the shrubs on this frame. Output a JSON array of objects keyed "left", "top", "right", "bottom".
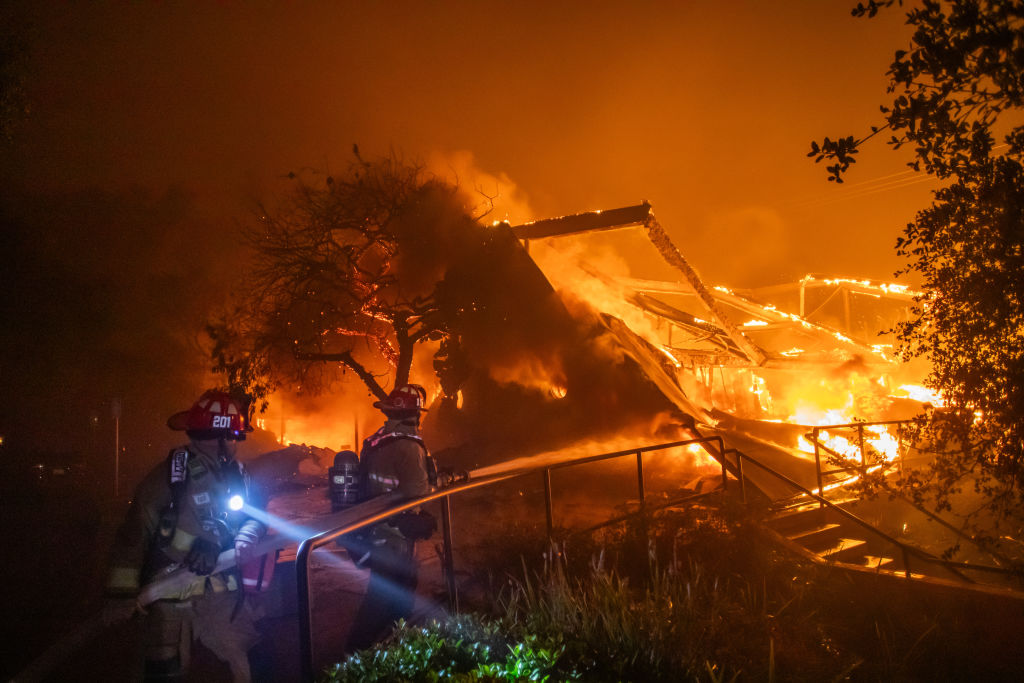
[{"left": 295, "top": 436, "right": 729, "bottom": 681}]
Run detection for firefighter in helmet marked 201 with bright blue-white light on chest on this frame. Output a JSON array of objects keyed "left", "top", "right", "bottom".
[{"left": 103, "top": 390, "right": 266, "bottom": 681}]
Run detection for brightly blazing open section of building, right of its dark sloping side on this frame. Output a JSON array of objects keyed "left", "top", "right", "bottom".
[{"left": 483, "top": 203, "right": 936, "bottom": 493}]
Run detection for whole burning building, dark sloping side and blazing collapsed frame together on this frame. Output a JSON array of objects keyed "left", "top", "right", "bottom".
[{"left": 251, "top": 194, "right": 924, "bottom": 505}]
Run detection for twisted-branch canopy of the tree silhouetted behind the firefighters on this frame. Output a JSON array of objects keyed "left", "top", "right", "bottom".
[{"left": 208, "top": 150, "right": 481, "bottom": 405}]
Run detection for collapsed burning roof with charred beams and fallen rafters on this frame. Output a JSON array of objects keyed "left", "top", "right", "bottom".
[{"left": 510, "top": 203, "right": 920, "bottom": 498}]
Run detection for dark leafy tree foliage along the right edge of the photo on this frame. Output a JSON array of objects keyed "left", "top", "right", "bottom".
[{"left": 808, "top": 0, "right": 1024, "bottom": 532}]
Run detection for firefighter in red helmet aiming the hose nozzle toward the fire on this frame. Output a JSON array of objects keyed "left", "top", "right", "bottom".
[{"left": 346, "top": 384, "right": 437, "bottom": 652}]
